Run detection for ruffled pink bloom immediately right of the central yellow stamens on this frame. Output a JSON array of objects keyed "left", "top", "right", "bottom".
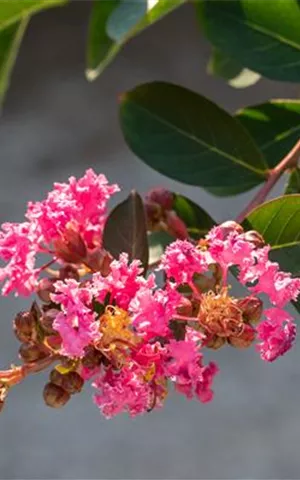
[{"left": 129, "top": 286, "right": 182, "bottom": 339}]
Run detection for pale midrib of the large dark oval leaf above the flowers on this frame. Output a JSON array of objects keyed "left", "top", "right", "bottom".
[{"left": 125, "top": 100, "right": 266, "bottom": 177}]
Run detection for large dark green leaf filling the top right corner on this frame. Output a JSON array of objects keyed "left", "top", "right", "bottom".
[{"left": 195, "top": 0, "right": 300, "bottom": 82}]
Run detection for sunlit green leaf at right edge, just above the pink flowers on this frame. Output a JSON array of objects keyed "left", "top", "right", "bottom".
[{"left": 244, "top": 195, "right": 300, "bottom": 276}]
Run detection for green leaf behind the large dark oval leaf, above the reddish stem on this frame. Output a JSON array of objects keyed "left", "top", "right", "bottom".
[{"left": 236, "top": 99, "right": 300, "bottom": 168}]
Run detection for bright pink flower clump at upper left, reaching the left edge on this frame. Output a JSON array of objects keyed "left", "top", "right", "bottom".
[{"left": 0, "top": 169, "right": 119, "bottom": 295}]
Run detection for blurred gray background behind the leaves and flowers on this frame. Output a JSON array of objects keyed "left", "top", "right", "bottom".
[{"left": 0, "top": 0, "right": 300, "bottom": 479}]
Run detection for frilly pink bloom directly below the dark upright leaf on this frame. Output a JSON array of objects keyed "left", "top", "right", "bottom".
[{"left": 93, "top": 253, "right": 154, "bottom": 310}]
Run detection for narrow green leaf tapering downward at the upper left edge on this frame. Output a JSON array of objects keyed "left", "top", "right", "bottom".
[{"left": 0, "top": 17, "right": 29, "bottom": 104}]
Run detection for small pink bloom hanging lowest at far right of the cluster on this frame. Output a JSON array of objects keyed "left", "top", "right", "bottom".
[{"left": 257, "top": 308, "right": 296, "bottom": 362}]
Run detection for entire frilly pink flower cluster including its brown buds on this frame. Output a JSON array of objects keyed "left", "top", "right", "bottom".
[{"left": 0, "top": 170, "right": 300, "bottom": 418}]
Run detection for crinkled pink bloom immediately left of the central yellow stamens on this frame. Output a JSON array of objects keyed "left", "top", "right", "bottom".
[{"left": 52, "top": 279, "right": 100, "bottom": 357}]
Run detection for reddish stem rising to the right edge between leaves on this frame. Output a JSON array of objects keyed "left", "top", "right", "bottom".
[{"left": 236, "top": 140, "right": 300, "bottom": 223}]
